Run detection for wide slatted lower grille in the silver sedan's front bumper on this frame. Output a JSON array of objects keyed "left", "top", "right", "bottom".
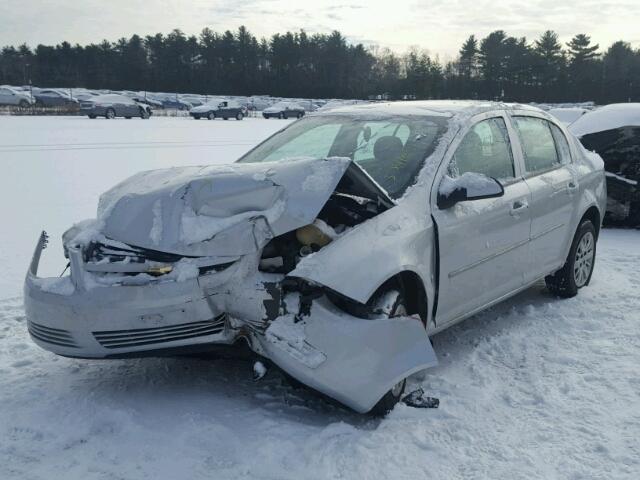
[{"left": 93, "top": 313, "right": 226, "bottom": 348}]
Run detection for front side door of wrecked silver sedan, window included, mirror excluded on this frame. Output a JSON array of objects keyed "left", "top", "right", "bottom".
[{"left": 431, "top": 114, "right": 531, "bottom": 329}]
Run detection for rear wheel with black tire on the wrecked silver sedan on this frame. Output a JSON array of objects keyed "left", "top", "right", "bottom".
[{"left": 545, "top": 220, "right": 597, "bottom": 298}]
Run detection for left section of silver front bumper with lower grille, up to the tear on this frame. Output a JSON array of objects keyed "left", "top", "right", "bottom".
[{"left": 24, "top": 235, "right": 240, "bottom": 358}]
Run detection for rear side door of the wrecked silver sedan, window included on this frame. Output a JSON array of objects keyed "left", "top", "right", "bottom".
[{"left": 511, "top": 112, "right": 579, "bottom": 281}]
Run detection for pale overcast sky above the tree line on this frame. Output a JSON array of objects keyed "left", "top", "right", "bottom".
[{"left": 0, "top": 0, "right": 640, "bottom": 59}]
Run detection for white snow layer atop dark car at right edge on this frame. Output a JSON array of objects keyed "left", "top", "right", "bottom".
[{"left": 569, "top": 103, "right": 640, "bottom": 137}]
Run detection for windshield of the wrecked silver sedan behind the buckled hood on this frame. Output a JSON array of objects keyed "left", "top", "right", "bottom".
[{"left": 238, "top": 115, "right": 447, "bottom": 198}]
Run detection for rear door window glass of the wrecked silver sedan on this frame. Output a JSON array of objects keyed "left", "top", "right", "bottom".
[{"left": 514, "top": 117, "right": 560, "bottom": 173}]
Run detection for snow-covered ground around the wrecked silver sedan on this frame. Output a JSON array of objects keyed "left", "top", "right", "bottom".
[{"left": 0, "top": 117, "right": 640, "bottom": 480}]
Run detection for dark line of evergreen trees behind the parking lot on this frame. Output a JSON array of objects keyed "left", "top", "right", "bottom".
[{"left": 0, "top": 27, "right": 640, "bottom": 104}]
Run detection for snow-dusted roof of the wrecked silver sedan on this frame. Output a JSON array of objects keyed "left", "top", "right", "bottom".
[{"left": 320, "top": 100, "right": 544, "bottom": 117}]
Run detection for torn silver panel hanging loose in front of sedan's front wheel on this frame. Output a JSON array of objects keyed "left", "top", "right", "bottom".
[{"left": 258, "top": 298, "right": 438, "bottom": 413}]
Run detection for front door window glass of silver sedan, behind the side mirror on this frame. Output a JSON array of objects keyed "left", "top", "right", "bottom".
[{"left": 448, "top": 118, "right": 515, "bottom": 180}]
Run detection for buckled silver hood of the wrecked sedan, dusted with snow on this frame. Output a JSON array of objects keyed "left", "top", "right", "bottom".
[{"left": 97, "top": 157, "right": 351, "bottom": 256}]
